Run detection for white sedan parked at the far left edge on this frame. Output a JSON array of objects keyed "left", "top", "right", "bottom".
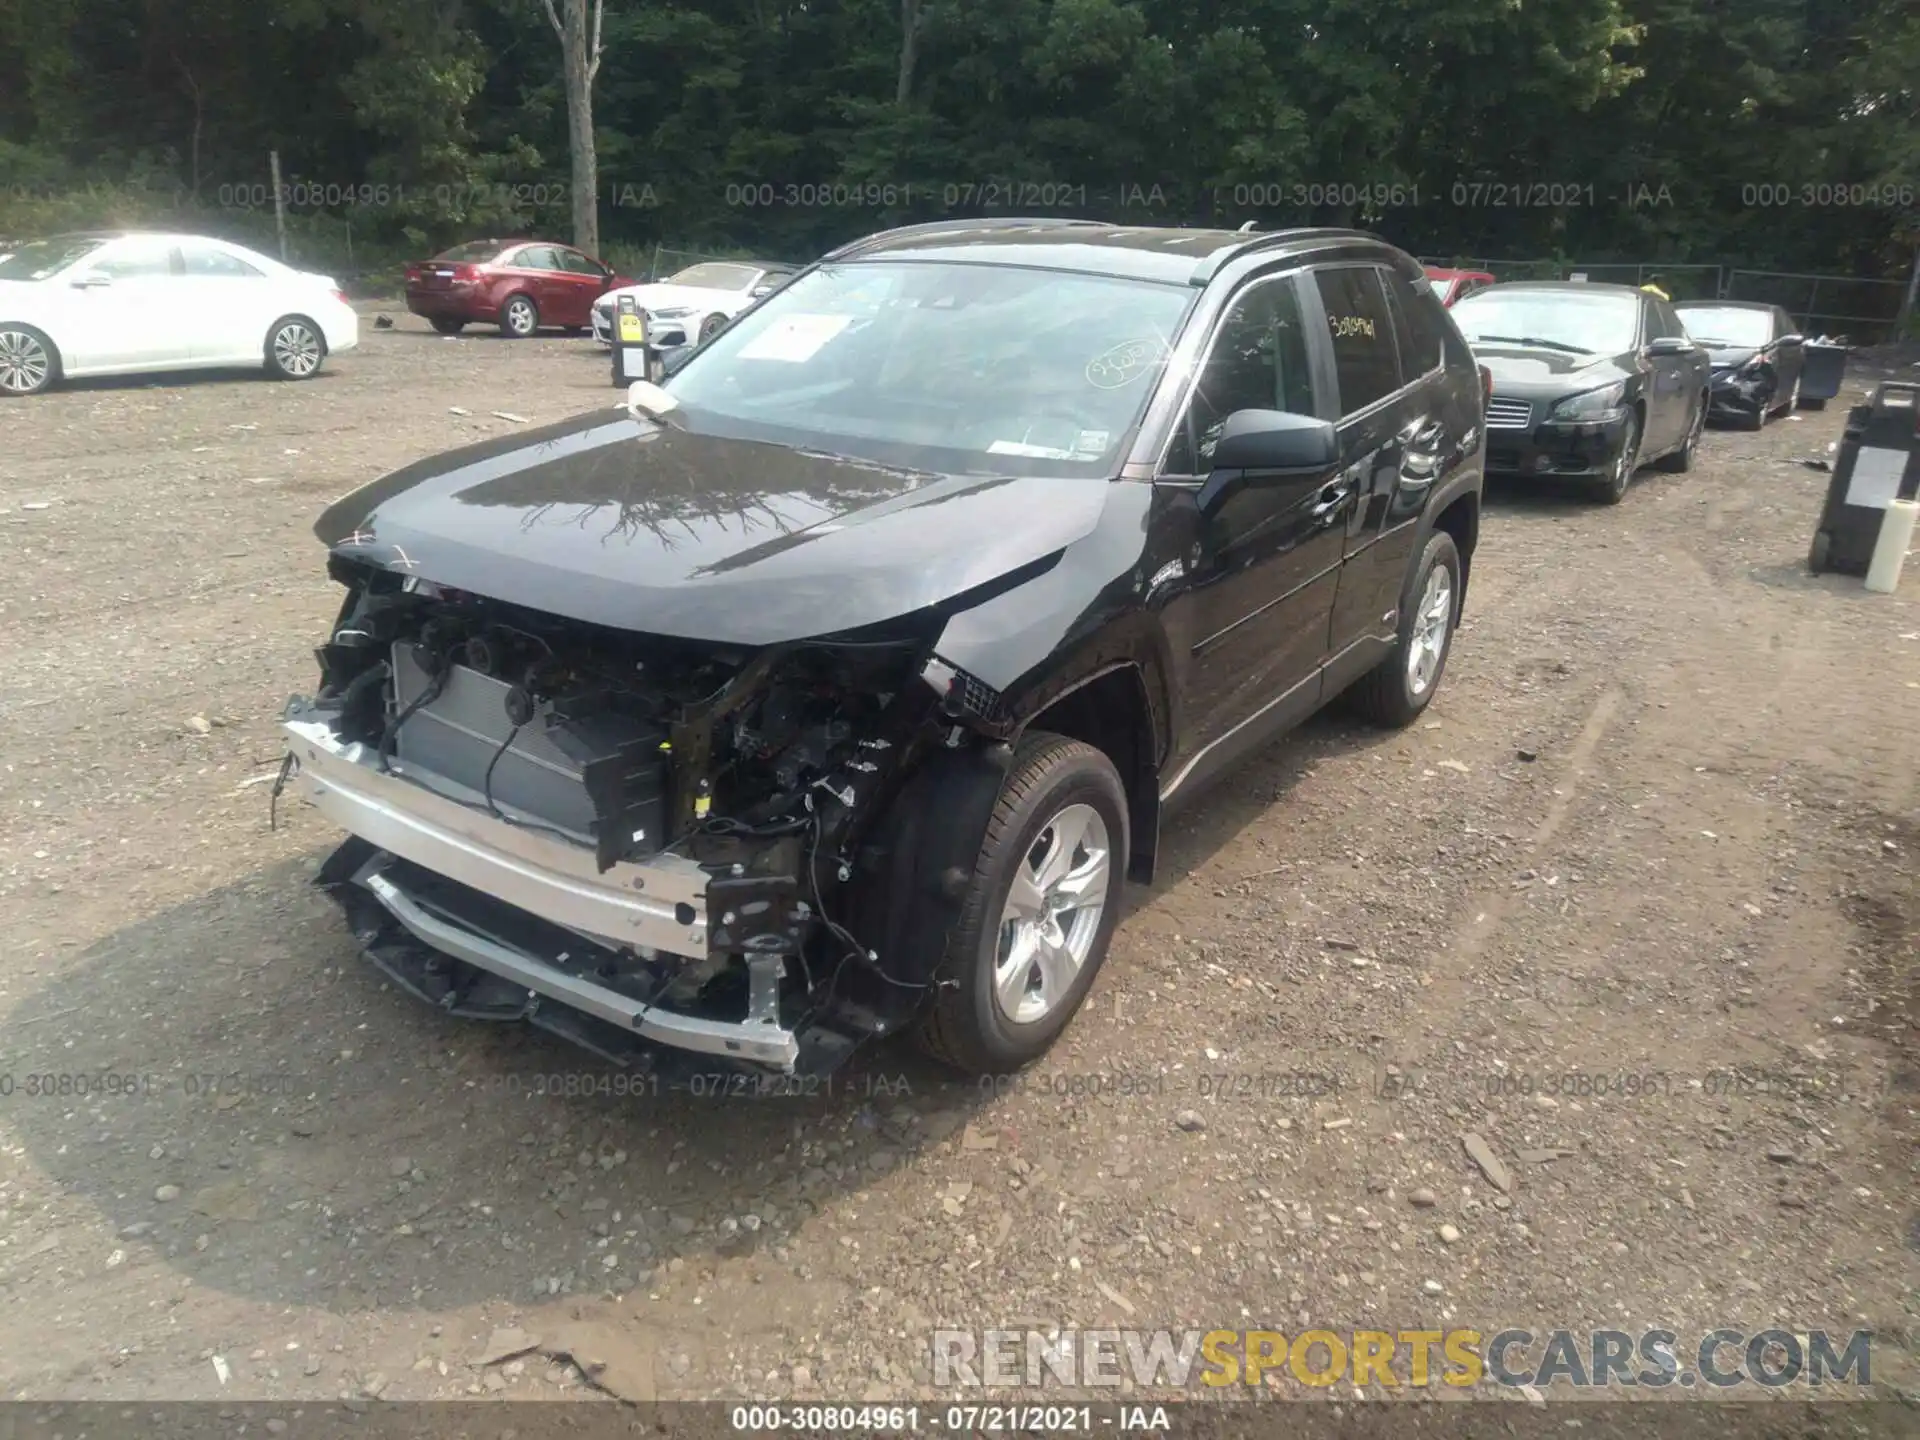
[{"left": 0, "top": 232, "right": 359, "bottom": 396}]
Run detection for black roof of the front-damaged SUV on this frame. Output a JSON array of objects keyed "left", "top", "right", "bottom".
[{"left": 826, "top": 217, "right": 1392, "bottom": 284}]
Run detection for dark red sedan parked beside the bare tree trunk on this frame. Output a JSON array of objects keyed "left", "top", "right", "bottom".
[{"left": 407, "top": 240, "right": 634, "bottom": 340}]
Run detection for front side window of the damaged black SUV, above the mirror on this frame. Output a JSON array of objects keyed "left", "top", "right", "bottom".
[{"left": 1167, "top": 278, "right": 1320, "bottom": 474}]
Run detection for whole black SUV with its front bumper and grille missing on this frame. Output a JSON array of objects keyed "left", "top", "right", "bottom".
[{"left": 282, "top": 221, "right": 1484, "bottom": 1083}]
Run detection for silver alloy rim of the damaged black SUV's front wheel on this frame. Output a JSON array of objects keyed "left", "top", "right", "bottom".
[{"left": 993, "top": 804, "right": 1112, "bottom": 1025}]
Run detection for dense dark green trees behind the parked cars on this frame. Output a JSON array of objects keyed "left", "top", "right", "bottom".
[{"left": 0, "top": 0, "right": 1920, "bottom": 289}]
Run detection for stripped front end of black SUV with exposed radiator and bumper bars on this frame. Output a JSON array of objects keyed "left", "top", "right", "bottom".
[{"left": 282, "top": 559, "right": 1021, "bottom": 1073}]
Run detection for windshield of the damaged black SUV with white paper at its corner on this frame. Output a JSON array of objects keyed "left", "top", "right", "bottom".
[{"left": 666, "top": 261, "right": 1194, "bottom": 476}]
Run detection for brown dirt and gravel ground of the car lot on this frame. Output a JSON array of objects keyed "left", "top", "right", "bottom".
[{"left": 0, "top": 305, "right": 1920, "bottom": 1400}]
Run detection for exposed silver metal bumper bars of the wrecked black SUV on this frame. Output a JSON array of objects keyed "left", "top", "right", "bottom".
[{"left": 282, "top": 701, "right": 803, "bottom": 1073}]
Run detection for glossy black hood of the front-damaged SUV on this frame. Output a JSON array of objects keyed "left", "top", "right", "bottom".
[{"left": 313, "top": 409, "right": 1108, "bottom": 645}]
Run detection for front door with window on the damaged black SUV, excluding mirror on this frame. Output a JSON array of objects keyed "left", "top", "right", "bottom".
[{"left": 1162, "top": 273, "right": 1352, "bottom": 774}]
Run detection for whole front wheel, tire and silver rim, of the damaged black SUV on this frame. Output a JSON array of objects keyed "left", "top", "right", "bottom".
[{"left": 918, "top": 732, "right": 1131, "bottom": 1075}]
